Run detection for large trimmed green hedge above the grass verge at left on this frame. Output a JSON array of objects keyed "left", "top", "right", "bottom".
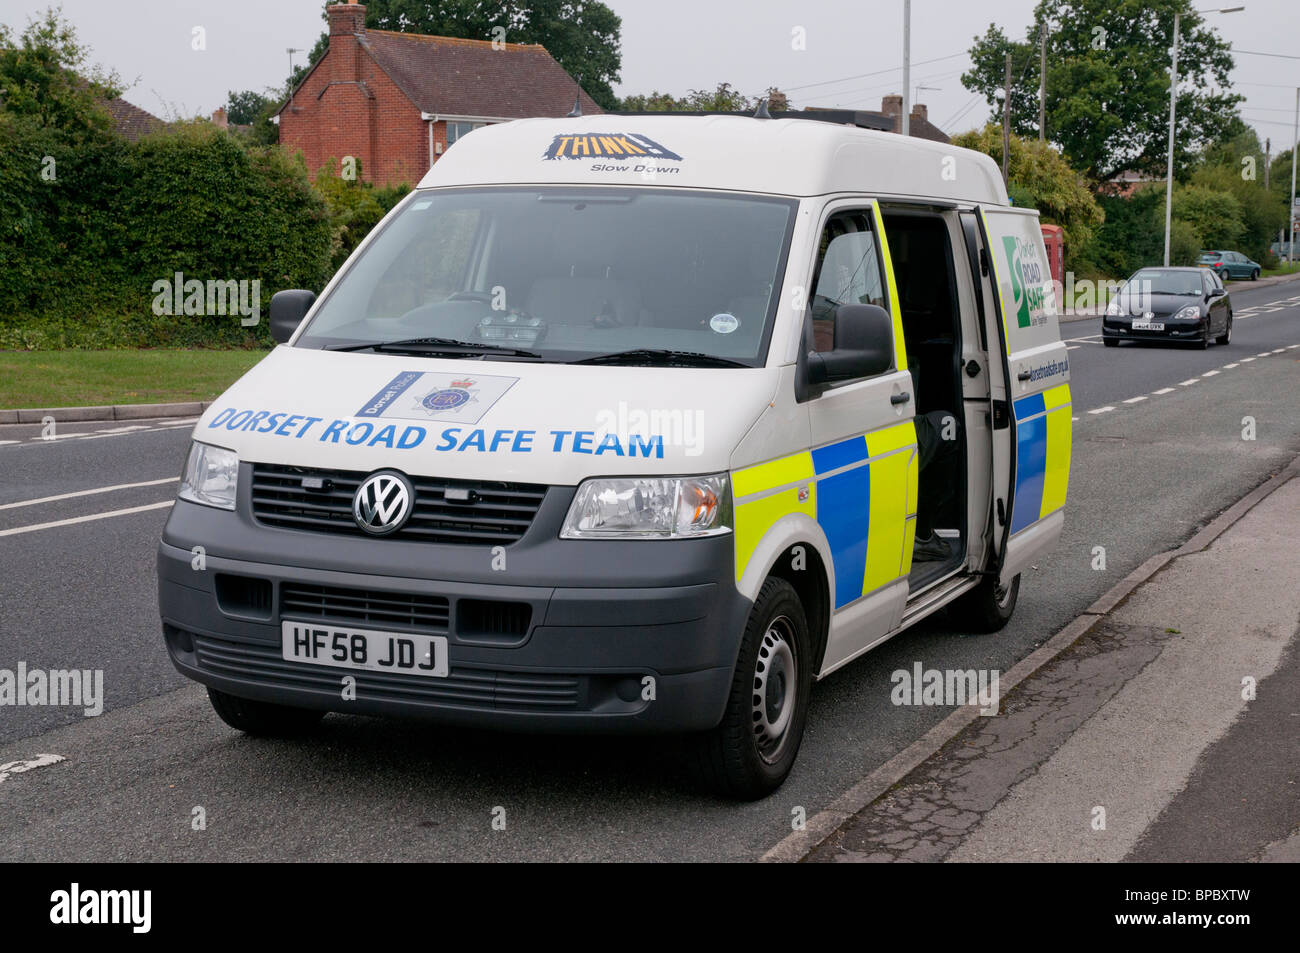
[{"left": 0, "top": 112, "right": 335, "bottom": 348}]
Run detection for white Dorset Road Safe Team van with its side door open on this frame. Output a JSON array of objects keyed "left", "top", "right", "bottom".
[{"left": 159, "top": 116, "right": 1071, "bottom": 797}]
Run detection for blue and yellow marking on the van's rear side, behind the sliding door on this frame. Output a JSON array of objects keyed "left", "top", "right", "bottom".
[{"left": 1011, "top": 384, "right": 1071, "bottom": 536}]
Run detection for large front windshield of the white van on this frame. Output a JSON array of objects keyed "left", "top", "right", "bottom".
[{"left": 295, "top": 187, "right": 797, "bottom": 367}]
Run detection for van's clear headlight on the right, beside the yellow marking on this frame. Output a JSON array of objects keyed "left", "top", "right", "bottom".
[{"left": 560, "top": 473, "right": 732, "bottom": 540}]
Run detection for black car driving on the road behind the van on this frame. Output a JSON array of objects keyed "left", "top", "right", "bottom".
[{"left": 1101, "top": 268, "right": 1232, "bottom": 347}]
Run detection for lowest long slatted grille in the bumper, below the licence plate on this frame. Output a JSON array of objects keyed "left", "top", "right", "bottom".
[{"left": 189, "top": 633, "right": 588, "bottom": 711}]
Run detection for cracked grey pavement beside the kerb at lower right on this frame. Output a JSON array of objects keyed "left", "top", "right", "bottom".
[{"left": 795, "top": 458, "right": 1300, "bottom": 862}]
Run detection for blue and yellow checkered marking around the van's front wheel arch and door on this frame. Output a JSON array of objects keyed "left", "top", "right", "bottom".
[{"left": 732, "top": 420, "right": 918, "bottom": 608}]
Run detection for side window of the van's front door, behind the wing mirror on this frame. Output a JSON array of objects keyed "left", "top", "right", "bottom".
[{"left": 811, "top": 211, "right": 887, "bottom": 351}]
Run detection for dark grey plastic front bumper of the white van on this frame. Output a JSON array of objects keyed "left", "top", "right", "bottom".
[{"left": 157, "top": 481, "right": 750, "bottom": 732}]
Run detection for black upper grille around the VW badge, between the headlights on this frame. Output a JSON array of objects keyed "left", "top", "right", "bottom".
[{"left": 252, "top": 463, "right": 546, "bottom": 546}]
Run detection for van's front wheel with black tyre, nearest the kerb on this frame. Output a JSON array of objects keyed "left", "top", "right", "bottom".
[{"left": 692, "top": 579, "right": 813, "bottom": 801}]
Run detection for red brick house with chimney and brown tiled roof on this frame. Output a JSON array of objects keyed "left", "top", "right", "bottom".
[{"left": 277, "top": 3, "right": 601, "bottom": 186}]
